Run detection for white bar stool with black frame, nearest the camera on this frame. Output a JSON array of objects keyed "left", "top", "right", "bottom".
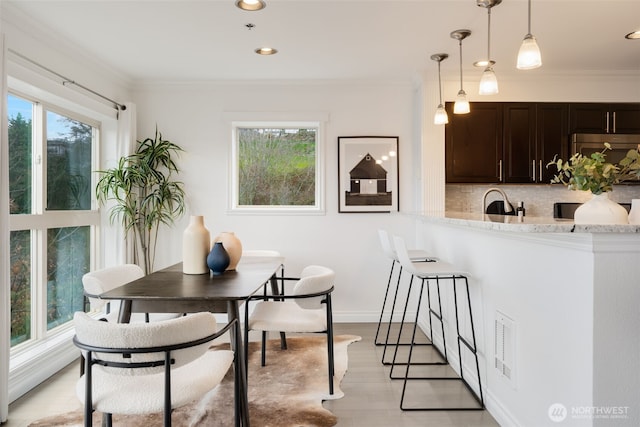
[{"left": 392, "top": 236, "right": 484, "bottom": 411}]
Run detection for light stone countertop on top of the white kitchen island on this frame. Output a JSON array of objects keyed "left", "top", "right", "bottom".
[{"left": 416, "top": 212, "right": 640, "bottom": 233}]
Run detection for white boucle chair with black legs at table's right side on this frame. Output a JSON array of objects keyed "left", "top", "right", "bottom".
[{"left": 244, "top": 265, "right": 335, "bottom": 394}]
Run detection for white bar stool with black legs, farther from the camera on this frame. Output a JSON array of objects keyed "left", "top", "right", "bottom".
[{"left": 374, "top": 229, "right": 436, "bottom": 365}]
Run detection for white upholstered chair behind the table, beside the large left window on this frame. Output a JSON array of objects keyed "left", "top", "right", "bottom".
[{"left": 82, "top": 264, "right": 181, "bottom": 323}]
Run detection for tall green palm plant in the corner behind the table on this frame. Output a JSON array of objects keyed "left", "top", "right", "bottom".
[{"left": 96, "top": 127, "right": 185, "bottom": 274}]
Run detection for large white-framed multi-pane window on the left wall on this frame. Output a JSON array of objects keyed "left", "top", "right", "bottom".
[{"left": 7, "top": 94, "right": 100, "bottom": 356}]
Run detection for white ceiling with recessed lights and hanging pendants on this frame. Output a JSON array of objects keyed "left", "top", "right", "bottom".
[{"left": 2, "top": 0, "right": 640, "bottom": 82}]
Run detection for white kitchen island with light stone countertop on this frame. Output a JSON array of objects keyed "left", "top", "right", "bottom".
[{"left": 410, "top": 212, "right": 640, "bottom": 426}]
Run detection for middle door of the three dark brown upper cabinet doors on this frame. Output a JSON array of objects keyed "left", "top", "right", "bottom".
[{"left": 502, "top": 102, "right": 537, "bottom": 183}]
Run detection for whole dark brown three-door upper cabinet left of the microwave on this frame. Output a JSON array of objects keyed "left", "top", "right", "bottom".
[{"left": 445, "top": 102, "right": 569, "bottom": 183}]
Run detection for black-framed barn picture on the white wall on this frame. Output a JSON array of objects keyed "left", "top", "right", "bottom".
[{"left": 338, "top": 136, "right": 400, "bottom": 212}]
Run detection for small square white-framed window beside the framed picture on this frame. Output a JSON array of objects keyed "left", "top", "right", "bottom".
[{"left": 231, "top": 122, "right": 324, "bottom": 213}]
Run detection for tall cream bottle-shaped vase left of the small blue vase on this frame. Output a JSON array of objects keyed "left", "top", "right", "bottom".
[{"left": 182, "top": 215, "right": 211, "bottom": 274}]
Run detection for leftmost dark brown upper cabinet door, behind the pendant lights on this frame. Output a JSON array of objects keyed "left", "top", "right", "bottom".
[{"left": 445, "top": 102, "right": 502, "bottom": 183}]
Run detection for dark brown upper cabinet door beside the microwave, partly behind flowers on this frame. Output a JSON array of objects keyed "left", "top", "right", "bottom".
[{"left": 536, "top": 103, "right": 570, "bottom": 184}]
